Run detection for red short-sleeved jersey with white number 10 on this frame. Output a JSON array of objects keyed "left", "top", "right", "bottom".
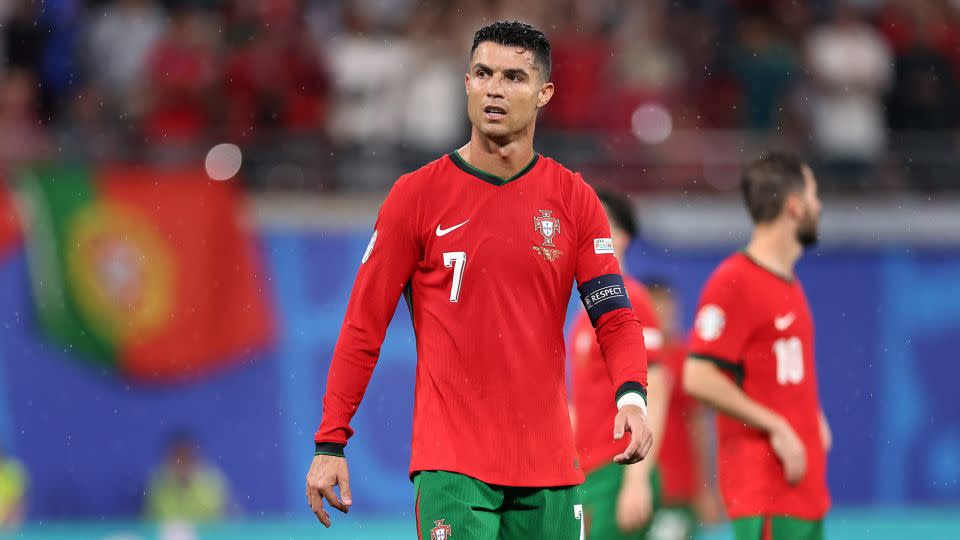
[{"left": 690, "top": 252, "right": 830, "bottom": 519}]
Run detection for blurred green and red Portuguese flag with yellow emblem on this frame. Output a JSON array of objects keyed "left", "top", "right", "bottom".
[{"left": 19, "top": 167, "right": 272, "bottom": 382}]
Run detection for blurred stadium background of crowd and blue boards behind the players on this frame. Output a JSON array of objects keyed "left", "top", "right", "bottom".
[{"left": 0, "top": 0, "right": 960, "bottom": 539}]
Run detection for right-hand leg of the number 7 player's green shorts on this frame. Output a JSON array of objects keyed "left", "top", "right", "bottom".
[{"left": 499, "top": 486, "right": 583, "bottom": 540}]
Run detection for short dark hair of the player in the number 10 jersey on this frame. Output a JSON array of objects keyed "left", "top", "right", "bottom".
[{"left": 740, "top": 152, "right": 806, "bottom": 223}]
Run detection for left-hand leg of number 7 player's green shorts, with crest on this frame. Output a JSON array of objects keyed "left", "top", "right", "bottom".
[{"left": 413, "top": 471, "right": 503, "bottom": 540}]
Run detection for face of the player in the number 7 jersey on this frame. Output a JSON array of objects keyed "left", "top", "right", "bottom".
[{"left": 465, "top": 41, "right": 553, "bottom": 144}]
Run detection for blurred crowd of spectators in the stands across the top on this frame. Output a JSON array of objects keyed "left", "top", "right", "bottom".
[{"left": 0, "top": 0, "right": 960, "bottom": 191}]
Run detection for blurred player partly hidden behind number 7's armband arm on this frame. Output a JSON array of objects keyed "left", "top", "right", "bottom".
[{"left": 570, "top": 190, "right": 668, "bottom": 540}]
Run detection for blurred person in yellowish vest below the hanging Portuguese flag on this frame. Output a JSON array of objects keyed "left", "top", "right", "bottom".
[{"left": 146, "top": 432, "right": 230, "bottom": 523}]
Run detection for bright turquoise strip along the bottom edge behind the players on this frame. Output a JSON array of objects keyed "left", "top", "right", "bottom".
[{"left": 7, "top": 507, "right": 960, "bottom": 540}]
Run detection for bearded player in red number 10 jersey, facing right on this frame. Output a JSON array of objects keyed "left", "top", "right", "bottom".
[{"left": 683, "top": 153, "right": 831, "bottom": 540}]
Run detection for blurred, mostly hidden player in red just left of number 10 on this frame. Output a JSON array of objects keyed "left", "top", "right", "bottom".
[{"left": 644, "top": 277, "right": 722, "bottom": 540}]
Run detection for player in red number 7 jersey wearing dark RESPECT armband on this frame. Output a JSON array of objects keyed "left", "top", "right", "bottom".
[{"left": 306, "top": 21, "right": 653, "bottom": 540}]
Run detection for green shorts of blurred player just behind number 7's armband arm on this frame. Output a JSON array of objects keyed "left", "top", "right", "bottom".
[{"left": 583, "top": 463, "right": 660, "bottom": 540}]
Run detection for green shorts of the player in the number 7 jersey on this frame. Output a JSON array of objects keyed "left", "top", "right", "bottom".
[{"left": 413, "top": 471, "right": 584, "bottom": 540}]
